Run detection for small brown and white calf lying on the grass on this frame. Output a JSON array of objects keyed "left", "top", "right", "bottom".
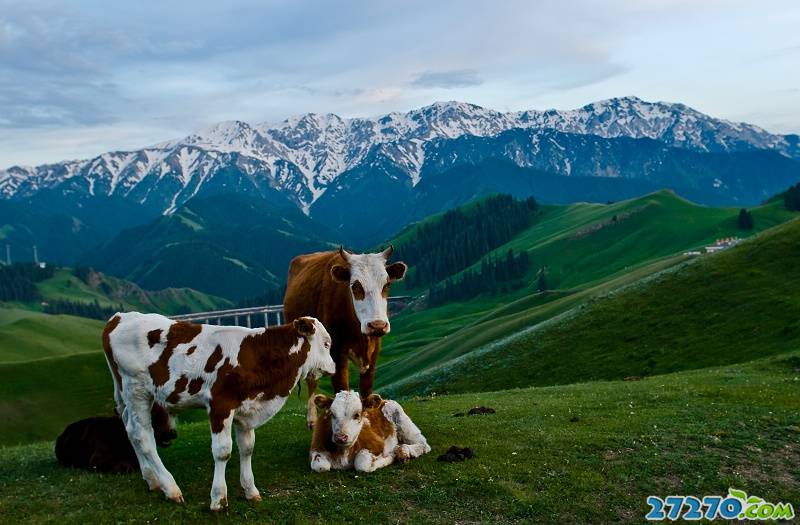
[{"left": 309, "top": 391, "right": 431, "bottom": 472}]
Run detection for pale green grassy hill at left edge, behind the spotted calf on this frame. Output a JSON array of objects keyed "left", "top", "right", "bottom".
[{"left": 0, "top": 308, "right": 103, "bottom": 362}]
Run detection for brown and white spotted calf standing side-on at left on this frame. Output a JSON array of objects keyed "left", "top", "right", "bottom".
[{"left": 103, "top": 312, "right": 336, "bottom": 510}]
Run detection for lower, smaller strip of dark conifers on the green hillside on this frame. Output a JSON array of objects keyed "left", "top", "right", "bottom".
[{"left": 428, "top": 250, "right": 530, "bottom": 306}]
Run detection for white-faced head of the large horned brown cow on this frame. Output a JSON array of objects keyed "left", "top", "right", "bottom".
[{"left": 331, "top": 246, "right": 408, "bottom": 337}]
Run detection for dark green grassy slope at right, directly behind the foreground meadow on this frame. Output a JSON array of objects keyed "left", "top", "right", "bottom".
[{"left": 389, "top": 215, "right": 800, "bottom": 394}]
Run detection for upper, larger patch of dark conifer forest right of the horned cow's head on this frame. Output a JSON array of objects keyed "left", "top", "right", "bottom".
[{"left": 395, "top": 195, "right": 539, "bottom": 288}]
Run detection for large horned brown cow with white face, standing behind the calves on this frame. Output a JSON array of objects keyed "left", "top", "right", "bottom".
[{"left": 283, "top": 246, "right": 407, "bottom": 428}]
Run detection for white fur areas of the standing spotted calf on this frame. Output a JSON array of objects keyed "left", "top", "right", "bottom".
[{"left": 109, "top": 312, "right": 336, "bottom": 510}]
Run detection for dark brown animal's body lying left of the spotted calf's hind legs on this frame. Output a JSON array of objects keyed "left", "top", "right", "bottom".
[{"left": 56, "top": 416, "right": 139, "bottom": 472}]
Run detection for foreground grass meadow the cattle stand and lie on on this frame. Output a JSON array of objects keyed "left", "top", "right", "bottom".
[{"left": 0, "top": 352, "right": 800, "bottom": 523}]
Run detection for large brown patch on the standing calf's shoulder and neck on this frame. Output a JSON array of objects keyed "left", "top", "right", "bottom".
[{"left": 209, "top": 325, "right": 311, "bottom": 433}]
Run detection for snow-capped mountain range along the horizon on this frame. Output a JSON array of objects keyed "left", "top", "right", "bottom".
[{"left": 0, "top": 97, "right": 800, "bottom": 213}]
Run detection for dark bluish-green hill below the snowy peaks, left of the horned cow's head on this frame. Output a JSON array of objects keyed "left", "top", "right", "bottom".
[{"left": 83, "top": 193, "right": 336, "bottom": 300}]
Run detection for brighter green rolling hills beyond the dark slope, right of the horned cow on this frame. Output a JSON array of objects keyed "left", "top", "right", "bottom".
[{"left": 378, "top": 191, "right": 793, "bottom": 378}]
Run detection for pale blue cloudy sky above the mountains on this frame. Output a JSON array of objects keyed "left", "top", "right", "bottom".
[{"left": 0, "top": 0, "right": 800, "bottom": 169}]
